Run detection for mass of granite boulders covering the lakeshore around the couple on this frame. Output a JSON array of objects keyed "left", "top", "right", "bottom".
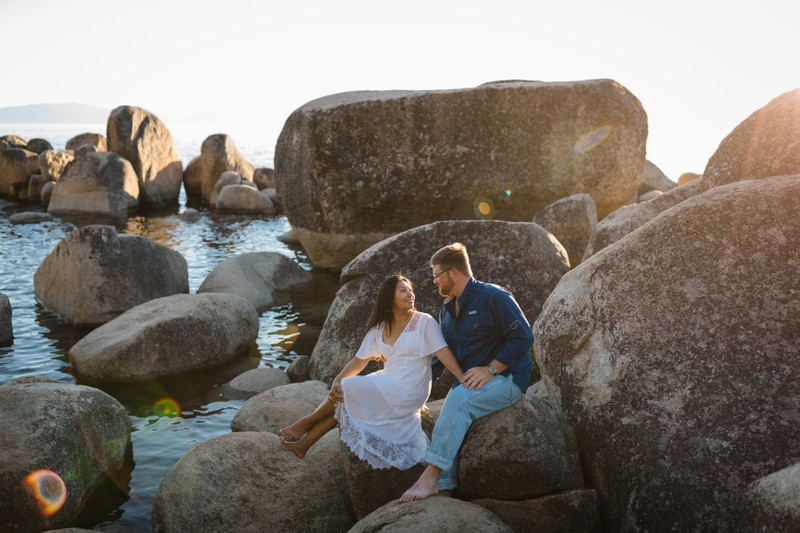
[{"left": 0, "top": 80, "right": 800, "bottom": 532}]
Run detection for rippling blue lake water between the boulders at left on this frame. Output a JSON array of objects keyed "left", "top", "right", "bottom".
[{"left": 0, "top": 124, "right": 338, "bottom": 531}]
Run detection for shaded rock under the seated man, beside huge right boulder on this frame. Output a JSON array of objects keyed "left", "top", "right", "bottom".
[{"left": 458, "top": 395, "right": 583, "bottom": 500}]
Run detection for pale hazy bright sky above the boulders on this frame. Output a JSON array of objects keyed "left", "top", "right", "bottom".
[{"left": 0, "top": 0, "right": 800, "bottom": 180}]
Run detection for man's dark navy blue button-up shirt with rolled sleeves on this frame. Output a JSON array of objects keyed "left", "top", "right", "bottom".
[{"left": 439, "top": 278, "right": 533, "bottom": 393}]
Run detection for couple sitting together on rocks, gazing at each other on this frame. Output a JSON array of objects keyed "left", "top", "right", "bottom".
[{"left": 280, "top": 243, "right": 533, "bottom": 502}]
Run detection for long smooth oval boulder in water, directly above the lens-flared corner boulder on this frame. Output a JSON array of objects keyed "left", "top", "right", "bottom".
[{"left": 69, "top": 294, "right": 258, "bottom": 381}]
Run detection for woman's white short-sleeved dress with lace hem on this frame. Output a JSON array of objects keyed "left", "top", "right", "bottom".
[{"left": 336, "top": 311, "right": 447, "bottom": 470}]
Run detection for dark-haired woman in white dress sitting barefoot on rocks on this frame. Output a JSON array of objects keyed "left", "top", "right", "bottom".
[{"left": 280, "top": 274, "right": 462, "bottom": 470}]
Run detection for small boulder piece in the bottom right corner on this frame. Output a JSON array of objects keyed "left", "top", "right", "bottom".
[{"left": 739, "top": 463, "right": 800, "bottom": 533}]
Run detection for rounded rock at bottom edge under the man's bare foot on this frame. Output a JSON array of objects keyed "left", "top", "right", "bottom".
[{"left": 349, "top": 496, "right": 514, "bottom": 533}]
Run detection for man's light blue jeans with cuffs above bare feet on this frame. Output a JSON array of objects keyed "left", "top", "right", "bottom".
[{"left": 425, "top": 375, "right": 522, "bottom": 490}]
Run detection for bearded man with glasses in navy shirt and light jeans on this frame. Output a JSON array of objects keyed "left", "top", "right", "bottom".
[{"left": 400, "top": 243, "right": 533, "bottom": 502}]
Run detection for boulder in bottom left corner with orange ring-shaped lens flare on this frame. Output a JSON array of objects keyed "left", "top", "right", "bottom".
[{"left": 0, "top": 376, "right": 132, "bottom": 532}]
